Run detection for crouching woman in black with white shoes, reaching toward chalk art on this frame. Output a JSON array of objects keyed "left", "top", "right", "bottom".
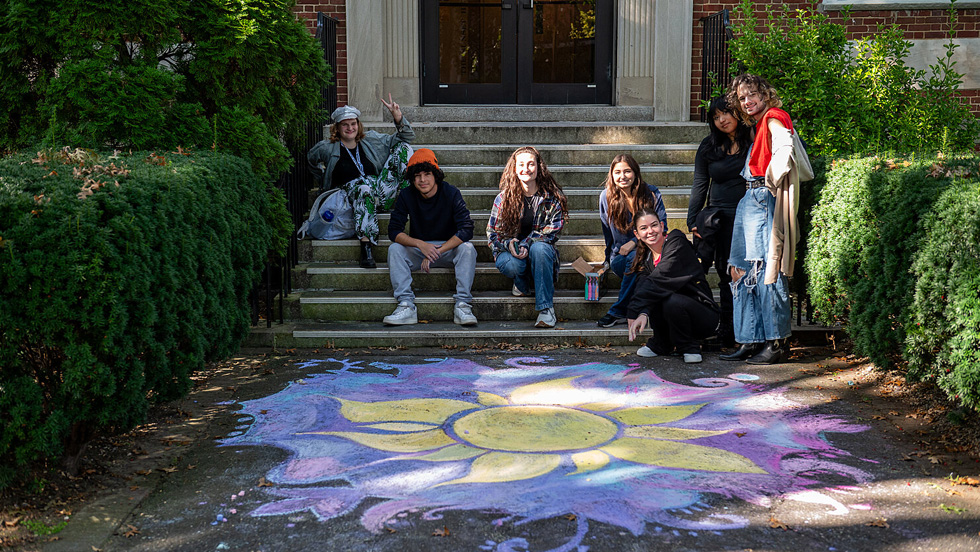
[{"left": 628, "top": 208, "right": 720, "bottom": 364}]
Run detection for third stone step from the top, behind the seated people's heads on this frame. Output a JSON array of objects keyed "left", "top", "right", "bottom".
[{"left": 417, "top": 143, "right": 698, "bottom": 165}]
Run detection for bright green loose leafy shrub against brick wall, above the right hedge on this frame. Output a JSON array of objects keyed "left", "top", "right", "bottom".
[{"left": 729, "top": 0, "right": 980, "bottom": 157}]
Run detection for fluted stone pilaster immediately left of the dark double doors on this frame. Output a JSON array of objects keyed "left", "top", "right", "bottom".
[{"left": 382, "top": 0, "right": 422, "bottom": 107}]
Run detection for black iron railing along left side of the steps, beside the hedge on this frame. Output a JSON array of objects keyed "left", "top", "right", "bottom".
[{"left": 251, "top": 13, "right": 337, "bottom": 327}]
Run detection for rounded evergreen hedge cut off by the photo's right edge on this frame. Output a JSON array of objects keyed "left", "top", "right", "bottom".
[{"left": 905, "top": 174, "right": 980, "bottom": 408}]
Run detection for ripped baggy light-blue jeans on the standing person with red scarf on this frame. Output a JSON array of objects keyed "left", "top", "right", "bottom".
[{"left": 728, "top": 187, "right": 791, "bottom": 343}]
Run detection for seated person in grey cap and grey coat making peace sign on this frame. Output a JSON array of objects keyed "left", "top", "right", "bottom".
[{"left": 306, "top": 94, "right": 415, "bottom": 268}]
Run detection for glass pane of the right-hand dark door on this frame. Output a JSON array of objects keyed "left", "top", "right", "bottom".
[{"left": 532, "top": 0, "right": 596, "bottom": 83}]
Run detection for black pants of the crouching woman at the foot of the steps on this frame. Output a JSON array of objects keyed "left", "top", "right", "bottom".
[{"left": 647, "top": 293, "right": 718, "bottom": 355}]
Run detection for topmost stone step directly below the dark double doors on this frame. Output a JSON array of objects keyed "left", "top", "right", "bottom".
[{"left": 398, "top": 105, "right": 653, "bottom": 124}]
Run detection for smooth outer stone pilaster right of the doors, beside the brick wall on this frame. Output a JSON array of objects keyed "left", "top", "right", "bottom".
[{"left": 653, "top": 0, "right": 694, "bottom": 121}]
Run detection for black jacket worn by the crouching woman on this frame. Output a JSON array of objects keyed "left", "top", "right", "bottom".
[{"left": 627, "top": 229, "right": 720, "bottom": 319}]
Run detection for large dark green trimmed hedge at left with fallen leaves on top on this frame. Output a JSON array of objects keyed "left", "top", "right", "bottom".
[{"left": 0, "top": 148, "right": 288, "bottom": 487}]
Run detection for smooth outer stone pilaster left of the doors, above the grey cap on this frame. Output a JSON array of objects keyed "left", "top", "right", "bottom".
[{"left": 347, "top": 0, "right": 386, "bottom": 121}]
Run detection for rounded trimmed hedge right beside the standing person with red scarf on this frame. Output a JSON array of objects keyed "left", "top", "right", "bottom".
[{"left": 805, "top": 157, "right": 976, "bottom": 367}]
